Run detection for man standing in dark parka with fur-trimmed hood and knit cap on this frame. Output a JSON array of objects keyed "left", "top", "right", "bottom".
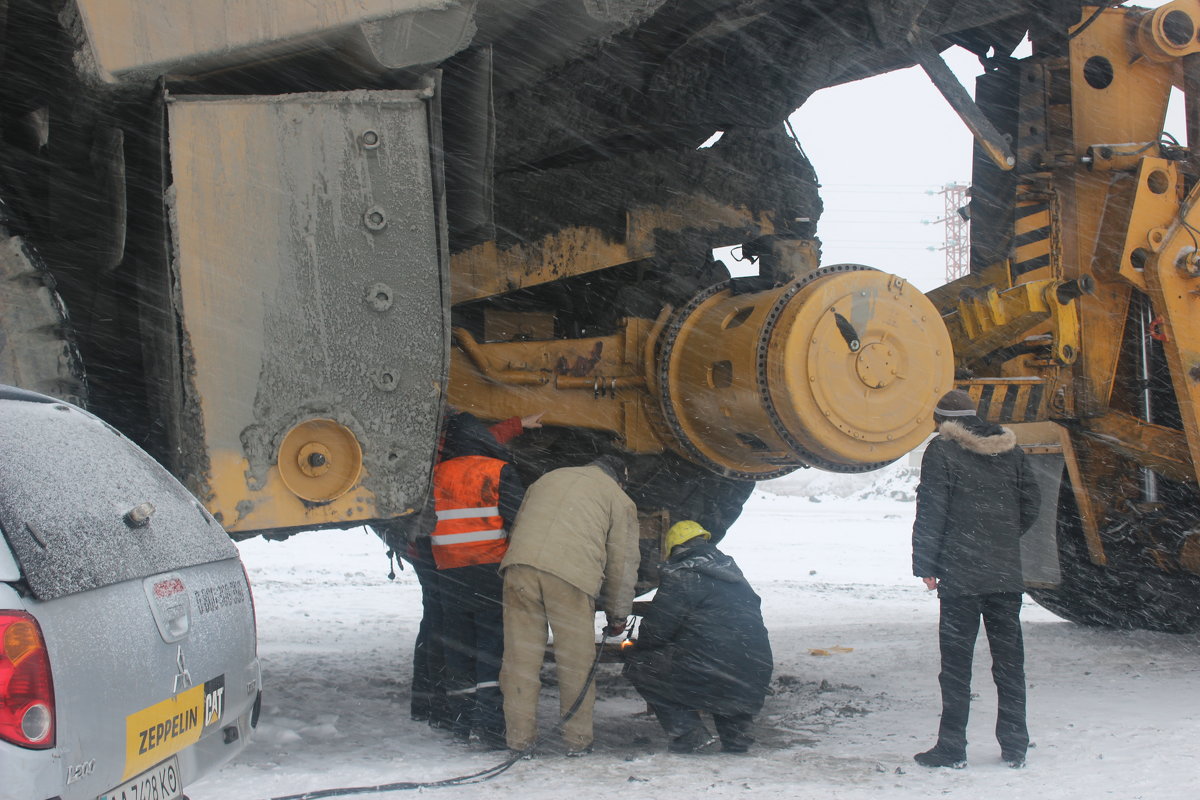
[{"left": 912, "top": 390, "right": 1040, "bottom": 768}]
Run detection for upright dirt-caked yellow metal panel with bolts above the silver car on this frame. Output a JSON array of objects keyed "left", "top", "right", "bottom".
[{"left": 168, "top": 91, "right": 446, "bottom": 533}]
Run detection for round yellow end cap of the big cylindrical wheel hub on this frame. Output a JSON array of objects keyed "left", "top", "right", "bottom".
[{"left": 760, "top": 265, "right": 953, "bottom": 473}]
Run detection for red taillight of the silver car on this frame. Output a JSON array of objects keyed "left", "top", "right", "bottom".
[{"left": 0, "top": 610, "right": 54, "bottom": 750}]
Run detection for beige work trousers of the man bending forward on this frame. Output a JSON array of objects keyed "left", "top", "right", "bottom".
[{"left": 500, "top": 564, "right": 596, "bottom": 750}]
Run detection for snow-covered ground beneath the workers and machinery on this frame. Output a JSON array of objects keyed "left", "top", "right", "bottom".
[{"left": 188, "top": 468, "right": 1200, "bottom": 800}]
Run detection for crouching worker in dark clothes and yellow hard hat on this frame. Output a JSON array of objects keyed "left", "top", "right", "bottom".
[{"left": 625, "top": 521, "right": 772, "bottom": 753}]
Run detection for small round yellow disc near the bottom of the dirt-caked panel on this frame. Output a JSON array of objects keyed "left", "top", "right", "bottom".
[{"left": 278, "top": 419, "right": 362, "bottom": 503}]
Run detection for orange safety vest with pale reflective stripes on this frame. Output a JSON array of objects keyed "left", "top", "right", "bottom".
[{"left": 431, "top": 456, "right": 509, "bottom": 570}]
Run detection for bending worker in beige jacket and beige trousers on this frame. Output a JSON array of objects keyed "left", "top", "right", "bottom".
[{"left": 500, "top": 456, "right": 640, "bottom": 756}]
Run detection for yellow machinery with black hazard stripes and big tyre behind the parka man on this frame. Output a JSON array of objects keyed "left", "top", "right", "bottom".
[{"left": 930, "top": 0, "right": 1200, "bottom": 631}]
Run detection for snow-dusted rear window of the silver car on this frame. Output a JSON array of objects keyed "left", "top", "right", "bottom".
[{"left": 0, "top": 399, "right": 238, "bottom": 600}]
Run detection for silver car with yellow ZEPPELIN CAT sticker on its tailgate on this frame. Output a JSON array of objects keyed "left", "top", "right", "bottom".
[{"left": 0, "top": 386, "right": 262, "bottom": 800}]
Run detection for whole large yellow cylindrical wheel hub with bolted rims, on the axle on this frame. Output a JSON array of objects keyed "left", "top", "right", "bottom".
[{"left": 658, "top": 264, "right": 954, "bottom": 480}]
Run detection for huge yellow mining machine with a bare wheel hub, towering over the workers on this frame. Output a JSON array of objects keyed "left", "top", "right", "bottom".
[{"left": 0, "top": 0, "right": 1200, "bottom": 630}]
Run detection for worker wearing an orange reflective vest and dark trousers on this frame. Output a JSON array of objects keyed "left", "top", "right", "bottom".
[{"left": 431, "top": 414, "right": 524, "bottom": 750}]
